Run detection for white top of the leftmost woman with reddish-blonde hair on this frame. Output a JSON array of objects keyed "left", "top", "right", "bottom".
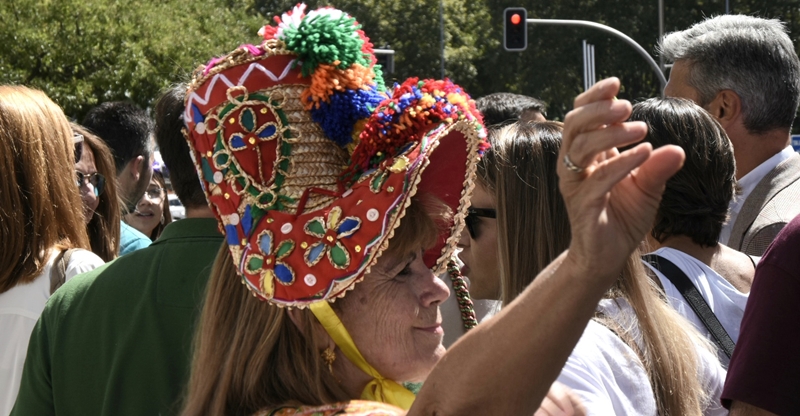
[{"left": 0, "top": 250, "right": 104, "bottom": 415}]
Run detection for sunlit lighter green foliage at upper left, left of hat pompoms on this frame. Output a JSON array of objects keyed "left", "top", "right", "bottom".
[{"left": 0, "top": 0, "right": 262, "bottom": 119}]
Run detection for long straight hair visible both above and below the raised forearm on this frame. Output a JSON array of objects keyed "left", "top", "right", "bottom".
[{"left": 479, "top": 122, "right": 708, "bottom": 415}]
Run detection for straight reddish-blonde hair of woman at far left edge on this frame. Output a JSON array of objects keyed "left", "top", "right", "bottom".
[{"left": 0, "top": 86, "right": 90, "bottom": 293}]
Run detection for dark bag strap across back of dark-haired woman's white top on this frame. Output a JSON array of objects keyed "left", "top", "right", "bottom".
[{"left": 642, "top": 254, "right": 735, "bottom": 358}]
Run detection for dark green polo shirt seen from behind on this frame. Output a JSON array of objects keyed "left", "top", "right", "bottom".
[{"left": 11, "top": 218, "right": 223, "bottom": 416}]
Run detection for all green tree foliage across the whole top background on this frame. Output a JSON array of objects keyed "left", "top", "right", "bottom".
[{"left": 0, "top": 0, "right": 800, "bottom": 132}]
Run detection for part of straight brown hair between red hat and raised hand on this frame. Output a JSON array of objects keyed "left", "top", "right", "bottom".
[{"left": 478, "top": 121, "right": 571, "bottom": 304}]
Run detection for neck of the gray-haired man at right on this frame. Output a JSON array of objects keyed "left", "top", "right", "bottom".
[{"left": 728, "top": 126, "right": 791, "bottom": 180}]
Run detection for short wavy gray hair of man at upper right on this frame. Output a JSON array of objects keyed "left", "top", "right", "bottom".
[{"left": 658, "top": 15, "right": 800, "bottom": 134}]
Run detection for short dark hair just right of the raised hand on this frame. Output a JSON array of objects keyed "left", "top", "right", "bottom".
[{"left": 630, "top": 98, "right": 736, "bottom": 247}]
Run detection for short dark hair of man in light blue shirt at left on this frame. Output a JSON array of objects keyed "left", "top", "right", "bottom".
[{"left": 81, "top": 101, "right": 153, "bottom": 174}]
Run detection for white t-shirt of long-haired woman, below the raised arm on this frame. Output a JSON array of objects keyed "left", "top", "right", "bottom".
[{"left": 558, "top": 299, "right": 728, "bottom": 416}]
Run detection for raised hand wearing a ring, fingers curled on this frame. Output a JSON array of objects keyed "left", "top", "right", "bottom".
[{"left": 558, "top": 78, "right": 684, "bottom": 283}]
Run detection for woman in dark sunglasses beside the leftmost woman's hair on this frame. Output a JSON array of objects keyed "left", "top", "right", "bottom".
[{"left": 71, "top": 123, "right": 120, "bottom": 262}]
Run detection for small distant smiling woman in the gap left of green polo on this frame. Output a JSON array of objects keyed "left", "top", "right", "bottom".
[{"left": 124, "top": 160, "right": 172, "bottom": 241}]
